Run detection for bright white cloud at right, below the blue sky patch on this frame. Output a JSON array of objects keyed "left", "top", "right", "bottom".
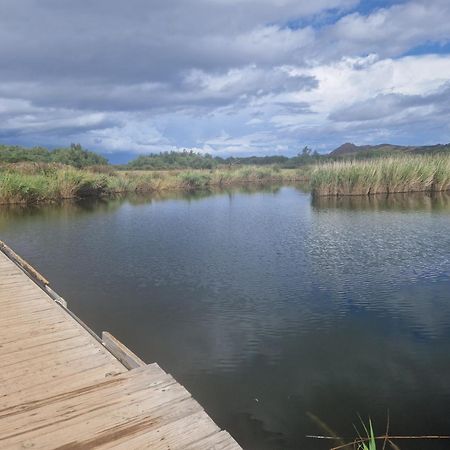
[{"left": 273, "top": 55, "right": 450, "bottom": 127}]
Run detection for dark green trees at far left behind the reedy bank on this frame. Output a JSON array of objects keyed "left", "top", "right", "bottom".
[{"left": 0, "top": 144, "right": 108, "bottom": 168}]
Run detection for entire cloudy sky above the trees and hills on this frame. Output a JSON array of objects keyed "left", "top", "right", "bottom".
[{"left": 0, "top": 0, "right": 450, "bottom": 162}]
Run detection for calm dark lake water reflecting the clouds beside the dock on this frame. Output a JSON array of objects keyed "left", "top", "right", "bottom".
[{"left": 0, "top": 187, "right": 450, "bottom": 449}]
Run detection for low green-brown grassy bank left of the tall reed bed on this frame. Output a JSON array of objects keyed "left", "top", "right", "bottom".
[{"left": 0, "top": 164, "right": 301, "bottom": 204}]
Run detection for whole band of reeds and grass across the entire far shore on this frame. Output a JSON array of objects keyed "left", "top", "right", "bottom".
[{"left": 4, "top": 155, "right": 450, "bottom": 204}]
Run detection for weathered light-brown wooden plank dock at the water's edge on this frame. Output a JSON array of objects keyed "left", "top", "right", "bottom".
[{"left": 0, "top": 242, "right": 241, "bottom": 450}]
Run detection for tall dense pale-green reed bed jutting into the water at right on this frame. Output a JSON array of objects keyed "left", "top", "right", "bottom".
[{"left": 309, "top": 155, "right": 450, "bottom": 196}]
